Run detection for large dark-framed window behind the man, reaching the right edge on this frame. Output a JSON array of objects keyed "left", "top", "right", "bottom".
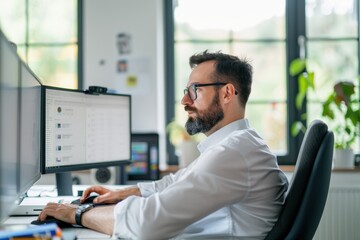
[{"left": 165, "top": 0, "right": 359, "bottom": 164}]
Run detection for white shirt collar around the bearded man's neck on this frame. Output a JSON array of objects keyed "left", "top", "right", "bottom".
[{"left": 198, "top": 118, "right": 250, "bottom": 153}]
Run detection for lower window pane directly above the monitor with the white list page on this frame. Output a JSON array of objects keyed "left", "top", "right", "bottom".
[{"left": 29, "top": 45, "right": 77, "bottom": 89}]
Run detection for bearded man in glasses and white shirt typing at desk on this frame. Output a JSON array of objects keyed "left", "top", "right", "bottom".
[{"left": 39, "top": 51, "right": 288, "bottom": 239}]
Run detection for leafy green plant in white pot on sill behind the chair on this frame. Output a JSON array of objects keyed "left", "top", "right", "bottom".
[{"left": 322, "top": 79, "right": 360, "bottom": 168}]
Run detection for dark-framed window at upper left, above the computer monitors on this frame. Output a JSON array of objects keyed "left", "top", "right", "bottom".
[{"left": 0, "top": 0, "right": 78, "bottom": 89}]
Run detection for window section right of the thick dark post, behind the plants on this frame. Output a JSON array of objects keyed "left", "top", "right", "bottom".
[{"left": 305, "top": 0, "right": 360, "bottom": 152}]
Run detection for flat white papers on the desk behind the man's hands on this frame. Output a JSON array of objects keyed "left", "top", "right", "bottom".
[{"left": 11, "top": 196, "right": 79, "bottom": 216}]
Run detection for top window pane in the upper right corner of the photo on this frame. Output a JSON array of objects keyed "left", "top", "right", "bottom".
[{"left": 306, "top": 0, "right": 358, "bottom": 38}]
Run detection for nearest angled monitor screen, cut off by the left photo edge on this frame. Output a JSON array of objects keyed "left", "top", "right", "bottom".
[{"left": 0, "top": 31, "right": 20, "bottom": 222}]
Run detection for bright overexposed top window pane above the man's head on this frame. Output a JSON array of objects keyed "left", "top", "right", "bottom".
[{"left": 174, "top": 0, "right": 285, "bottom": 40}]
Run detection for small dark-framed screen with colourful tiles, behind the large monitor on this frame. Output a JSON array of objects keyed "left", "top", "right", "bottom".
[{"left": 127, "top": 133, "right": 159, "bottom": 181}]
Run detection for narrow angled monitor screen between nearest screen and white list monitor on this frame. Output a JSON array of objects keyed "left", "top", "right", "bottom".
[{"left": 19, "top": 63, "right": 41, "bottom": 193}]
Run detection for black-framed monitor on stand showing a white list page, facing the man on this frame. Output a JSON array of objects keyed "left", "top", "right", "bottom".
[{"left": 41, "top": 86, "right": 131, "bottom": 195}]
